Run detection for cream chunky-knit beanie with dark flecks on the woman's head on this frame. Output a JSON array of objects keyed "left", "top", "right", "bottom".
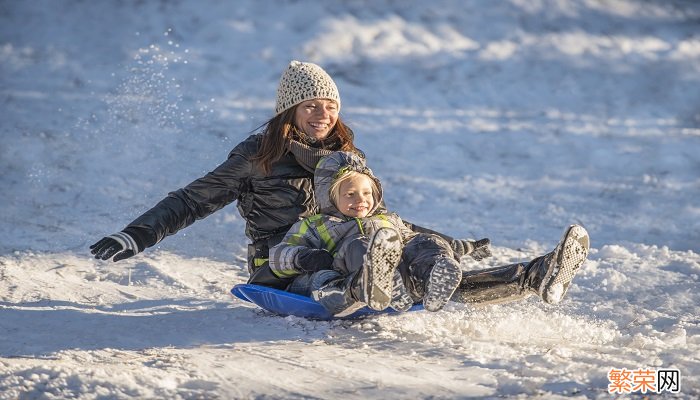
[{"left": 275, "top": 60, "right": 340, "bottom": 115}]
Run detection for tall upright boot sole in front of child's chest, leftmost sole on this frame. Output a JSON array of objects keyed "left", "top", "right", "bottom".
[{"left": 363, "top": 228, "right": 403, "bottom": 311}]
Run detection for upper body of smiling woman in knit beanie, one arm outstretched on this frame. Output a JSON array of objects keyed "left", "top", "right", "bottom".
[{"left": 90, "top": 61, "right": 361, "bottom": 287}]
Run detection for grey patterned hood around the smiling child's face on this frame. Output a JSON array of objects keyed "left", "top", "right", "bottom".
[{"left": 314, "top": 151, "right": 384, "bottom": 218}]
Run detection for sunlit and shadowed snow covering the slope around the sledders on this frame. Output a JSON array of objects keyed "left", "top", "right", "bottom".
[{"left": 0, "top": 0, "right": 700, "bottom": 399}]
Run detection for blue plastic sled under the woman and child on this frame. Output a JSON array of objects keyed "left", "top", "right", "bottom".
[{"left": 231, "top": 284, "right": 423, "bottom": 320}]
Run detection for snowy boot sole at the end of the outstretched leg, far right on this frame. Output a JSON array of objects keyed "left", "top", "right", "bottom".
[{"left": 542, "top": 225, "right": 590, "bottom": 304}]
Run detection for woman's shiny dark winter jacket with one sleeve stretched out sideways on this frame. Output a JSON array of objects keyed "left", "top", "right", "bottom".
[{"left": 124, "top": 135, "right": 317, "bottom": 268}]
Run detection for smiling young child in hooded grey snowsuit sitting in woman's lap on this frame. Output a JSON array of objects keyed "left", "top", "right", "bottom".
[{"left": 270, "top": 152, "right": 476, "bottom": 316}]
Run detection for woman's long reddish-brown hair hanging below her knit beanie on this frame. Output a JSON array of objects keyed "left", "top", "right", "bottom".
[{"left": 253, "top": 105, "right": 359, "bottom": 175}]
